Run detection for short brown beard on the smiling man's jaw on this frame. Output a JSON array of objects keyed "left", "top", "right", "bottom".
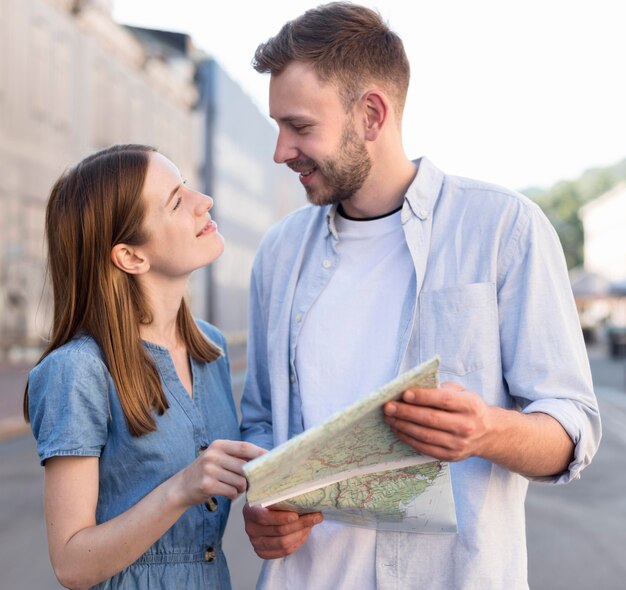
[{"left": 304, "top": 123, "right": 372, "bottom": 206}]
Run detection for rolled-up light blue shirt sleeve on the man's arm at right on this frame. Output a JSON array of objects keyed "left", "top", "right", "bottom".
[{"left": 498, "top": 206, "right": 602, "bottom": 483}]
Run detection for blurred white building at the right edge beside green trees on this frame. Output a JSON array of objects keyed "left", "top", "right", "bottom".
[{"left": 579, "top": 183, "right": 626, "bottom": 282}]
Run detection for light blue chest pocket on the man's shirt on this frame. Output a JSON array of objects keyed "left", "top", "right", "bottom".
[{"left": 419, "top": 283, "right": 500, "bottom": 375}]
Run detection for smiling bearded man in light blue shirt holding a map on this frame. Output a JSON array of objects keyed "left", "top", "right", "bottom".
[{"left": 242, "top": 3, "right": 600, "bottom": 590}]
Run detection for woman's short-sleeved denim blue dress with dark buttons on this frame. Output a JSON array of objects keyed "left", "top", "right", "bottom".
[{"left": 28, "top": 321, "right": 239, "bottom": 590}]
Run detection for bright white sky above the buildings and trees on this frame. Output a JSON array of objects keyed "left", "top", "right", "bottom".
[{"left": 113, "top": 0, "right": 626, "bottom": 190}]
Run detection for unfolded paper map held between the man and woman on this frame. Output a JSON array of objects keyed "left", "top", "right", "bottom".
[{"left": 244, "top": 357, "right": 456, "bottom": 533}]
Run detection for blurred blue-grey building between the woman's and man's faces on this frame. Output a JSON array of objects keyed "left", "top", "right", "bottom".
[{"left": 130, "top": 27, "right": 304, "bottom": 338}]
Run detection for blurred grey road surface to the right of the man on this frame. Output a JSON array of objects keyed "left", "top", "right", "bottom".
[{"left": 526, "top": 349, "right": 626, "bottom": 590}]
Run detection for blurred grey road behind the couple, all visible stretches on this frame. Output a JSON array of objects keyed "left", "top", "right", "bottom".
[{"left": 0, "top": 351, "right": 626, "bottom": 590}]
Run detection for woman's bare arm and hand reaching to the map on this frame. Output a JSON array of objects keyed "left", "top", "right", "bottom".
[{"left": 45, "top": 440, "right": 266, "bottom": 588}]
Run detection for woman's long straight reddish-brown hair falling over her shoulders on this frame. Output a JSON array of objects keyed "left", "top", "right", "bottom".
[{"left": 24, "top": 145, "right": 222, "bottom": 436}]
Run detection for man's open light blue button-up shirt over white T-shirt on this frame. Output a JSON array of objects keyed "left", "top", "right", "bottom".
[{"left": 242, "top": 158, "right": 601, "bottom": 590}]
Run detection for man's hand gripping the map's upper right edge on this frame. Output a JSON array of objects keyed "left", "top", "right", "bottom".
[{"left": 384, "top": 383, "right": 491, "bottom": 461}]
